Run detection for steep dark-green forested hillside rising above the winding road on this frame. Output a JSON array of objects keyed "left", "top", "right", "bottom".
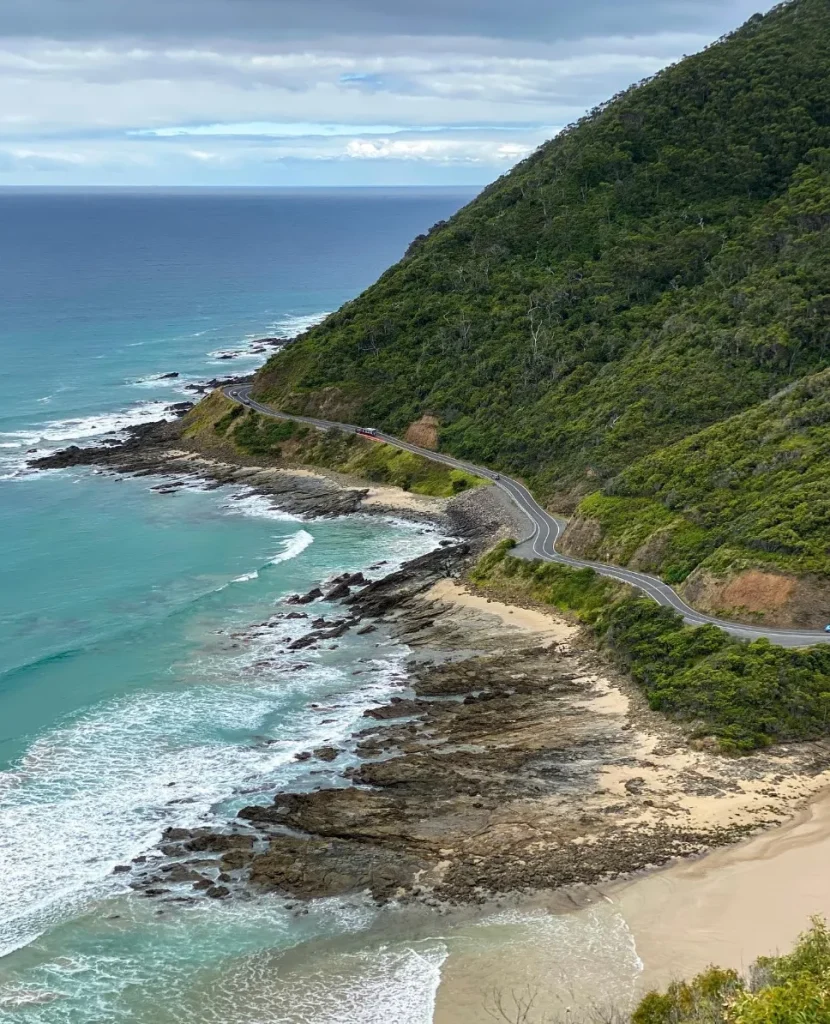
[{"left": 257, "top": 0, "right": 830, "bottom": 614}]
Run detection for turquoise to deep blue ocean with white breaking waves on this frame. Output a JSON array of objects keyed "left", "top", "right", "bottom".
[{"left": 0, "top": 189, "right": 636, "bottom": 1024}]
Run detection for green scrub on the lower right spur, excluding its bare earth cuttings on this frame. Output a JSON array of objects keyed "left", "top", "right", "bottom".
[{"left": 579, "top": 370, "right": 830, "bottom": 582}]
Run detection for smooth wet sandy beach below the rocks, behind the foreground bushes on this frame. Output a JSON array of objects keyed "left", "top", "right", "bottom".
[{"left": 433, "top": 791, "right": 830, "bottom": 1024}]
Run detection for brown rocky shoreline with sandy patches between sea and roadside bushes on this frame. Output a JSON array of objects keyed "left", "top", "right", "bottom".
[{"left": 34, "top": 405, "right": 830, "bottom": 912}]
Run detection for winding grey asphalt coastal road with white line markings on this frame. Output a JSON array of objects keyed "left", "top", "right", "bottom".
[{"left": 223, "top": 384, "right": 830, "bottom": 647}]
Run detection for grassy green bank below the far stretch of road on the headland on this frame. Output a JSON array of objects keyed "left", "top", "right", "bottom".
[{"left": 183, "top": 391, "right": 485, "bottom": 498}]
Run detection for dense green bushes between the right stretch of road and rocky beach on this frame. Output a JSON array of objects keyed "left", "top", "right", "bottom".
[{"left": 473, "top": 541, "right": 830, "bottom": 753}]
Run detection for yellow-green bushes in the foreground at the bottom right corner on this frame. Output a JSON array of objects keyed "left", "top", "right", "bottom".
[{"left": 631, "top": 919, "right": 830, "bottom": 1024}]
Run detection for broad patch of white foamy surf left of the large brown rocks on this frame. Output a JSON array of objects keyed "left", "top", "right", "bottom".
[{"left": 0, "top": 581, "right": 415, "bottom": 956}]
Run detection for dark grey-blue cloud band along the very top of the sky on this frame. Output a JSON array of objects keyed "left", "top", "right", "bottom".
[{"left": 0, "top": 0, "right": 755, "bottom": 43}]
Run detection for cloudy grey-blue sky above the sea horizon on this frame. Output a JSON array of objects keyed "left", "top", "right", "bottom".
[{"left": 0, "top": 0, "right": 772, "bottom": 186}]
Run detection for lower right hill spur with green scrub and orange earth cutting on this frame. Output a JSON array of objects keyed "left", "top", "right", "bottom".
[{"left": 563, "top": 371, "right": 830, "bottom": 628}]
